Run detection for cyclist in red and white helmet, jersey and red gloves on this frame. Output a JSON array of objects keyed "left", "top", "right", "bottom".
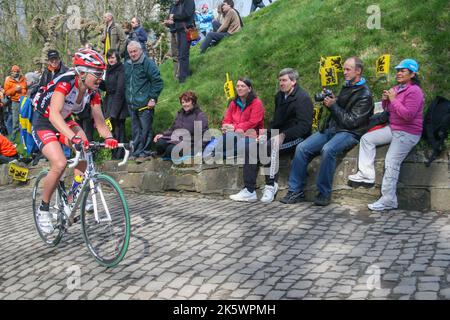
[{"left": 32, "top": 49, "right": 118, "bottom": 233}]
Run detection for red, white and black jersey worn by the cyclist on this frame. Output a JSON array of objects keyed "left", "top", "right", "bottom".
[{"left": 33, "top": 70, "right": 101, "bottom": 119}]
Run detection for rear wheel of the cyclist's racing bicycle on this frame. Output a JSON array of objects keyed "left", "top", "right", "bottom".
[{"left": 32, "top": 170, "right": 64, "bottom": 247}]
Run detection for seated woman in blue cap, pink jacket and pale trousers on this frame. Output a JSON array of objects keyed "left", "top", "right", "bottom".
[{"left": 348, "top": 59, "right": 424, "bottom": 211}]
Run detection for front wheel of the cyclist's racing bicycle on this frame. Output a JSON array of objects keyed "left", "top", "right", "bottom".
[{"left": 80, "top": 174, "right": 130, "bottom": 267}]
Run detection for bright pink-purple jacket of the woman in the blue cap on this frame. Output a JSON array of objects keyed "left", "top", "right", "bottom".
[{"left": 383, "top": 83, "right": 424, "bottom": 135}]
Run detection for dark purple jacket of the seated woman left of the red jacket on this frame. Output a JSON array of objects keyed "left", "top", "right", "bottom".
[{"left": 162, "top": 106, "right": 208, "bottom": 144}]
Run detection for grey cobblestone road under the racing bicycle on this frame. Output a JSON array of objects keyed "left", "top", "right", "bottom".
[{"left": 0, "top": 187, "right": 450, "bottom": 299}]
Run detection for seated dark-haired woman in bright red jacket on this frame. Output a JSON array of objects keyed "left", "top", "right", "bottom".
[{"left": 204, "top": 78, "right": 264, "bottom": 160}]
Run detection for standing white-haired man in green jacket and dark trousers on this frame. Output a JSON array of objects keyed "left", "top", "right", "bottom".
[{"left": 125, "top": 41, "right": 164, "bottom": 160}]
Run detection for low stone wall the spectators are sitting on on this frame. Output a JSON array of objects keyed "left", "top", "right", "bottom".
[{"left": 0, "top": 146, "right": 450, "bottom": 210}]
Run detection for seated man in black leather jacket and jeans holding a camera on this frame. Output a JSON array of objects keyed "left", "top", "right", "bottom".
[{"left": 280, "top": 57, "right": 373, "bottom": 206}]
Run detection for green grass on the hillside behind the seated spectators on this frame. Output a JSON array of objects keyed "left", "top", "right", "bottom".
[{"left": 154, "top": 0, "right": 450, "bottom": 136}]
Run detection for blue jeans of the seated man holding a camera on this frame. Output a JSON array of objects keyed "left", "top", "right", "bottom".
[{"left": 288, "top": 129, "right": 359, "bottom": 195}]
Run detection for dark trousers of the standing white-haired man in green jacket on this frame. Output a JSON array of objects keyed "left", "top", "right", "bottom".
[{"left": 129, "top": 108, "right": 155, "bottom": 157}]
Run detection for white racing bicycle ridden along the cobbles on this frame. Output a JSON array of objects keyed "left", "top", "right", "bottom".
[{"left": 32, "top": 142, "right": 133, "bottom": 267}]
